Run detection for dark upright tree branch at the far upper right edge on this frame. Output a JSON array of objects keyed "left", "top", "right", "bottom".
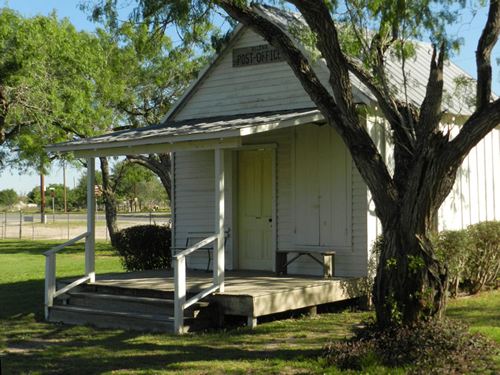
[{"left": 476, "top": 0, "right": 500, "bottom": 109}]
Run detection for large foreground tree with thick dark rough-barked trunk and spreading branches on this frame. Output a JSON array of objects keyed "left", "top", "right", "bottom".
[{"left": 88, "top": 0, "right": 500, "bottom": 326}]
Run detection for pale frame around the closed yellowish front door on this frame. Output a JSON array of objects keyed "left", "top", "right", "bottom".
[{"left": 232, "top": 143, "right": 278, "bottom": 272}]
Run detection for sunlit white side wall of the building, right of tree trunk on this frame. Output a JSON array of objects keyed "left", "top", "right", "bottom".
[{"left": 438, "top": 126, "right": 500, "bottom": 230}]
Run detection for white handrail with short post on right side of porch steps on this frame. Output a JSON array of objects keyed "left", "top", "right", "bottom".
[{"left": 173, "top": 234, "right": 220, "bottom": 334}]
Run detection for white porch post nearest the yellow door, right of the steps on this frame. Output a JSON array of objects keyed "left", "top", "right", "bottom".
[{"left": 213, "top": 148, "right": 225, "bottom": 292}]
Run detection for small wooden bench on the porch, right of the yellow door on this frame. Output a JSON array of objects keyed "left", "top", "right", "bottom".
[{"left": 276, "top": 247, "right": 335, "bottom": 278}]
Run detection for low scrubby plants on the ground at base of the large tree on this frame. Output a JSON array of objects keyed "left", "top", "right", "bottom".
[{"left": 324, "top": 320, "right": 499, "bottom": 374}]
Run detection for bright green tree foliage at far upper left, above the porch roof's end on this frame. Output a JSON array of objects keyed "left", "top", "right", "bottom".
[{"left": 0, "top": 8, "right": 112, "bottom": 170}]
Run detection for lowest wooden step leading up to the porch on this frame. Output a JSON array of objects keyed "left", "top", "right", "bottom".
[{"left": 48, "top": 306, "right": 178, "bottom": 332}]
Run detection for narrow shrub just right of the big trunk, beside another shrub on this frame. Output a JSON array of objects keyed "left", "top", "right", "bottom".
[{"left": 432, "top": 230, "right": 471, "bottom": 296}]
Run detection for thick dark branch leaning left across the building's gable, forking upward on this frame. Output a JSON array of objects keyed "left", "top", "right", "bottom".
[{"left": 215, "top": 0, "right": 397, "bottom": 217}]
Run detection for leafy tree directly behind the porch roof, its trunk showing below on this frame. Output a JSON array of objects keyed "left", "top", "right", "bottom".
[{"left": 92, "top": 21, "right": 209, "bottom": 243}]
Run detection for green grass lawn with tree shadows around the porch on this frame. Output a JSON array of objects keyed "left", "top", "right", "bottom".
[{"left": 0, "top": 241, "right": 500, "bottom": 375}]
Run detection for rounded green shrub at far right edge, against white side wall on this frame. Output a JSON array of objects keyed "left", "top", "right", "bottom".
[{"left": 465, "top": 221, "right": 500, "bottom": 294}]
